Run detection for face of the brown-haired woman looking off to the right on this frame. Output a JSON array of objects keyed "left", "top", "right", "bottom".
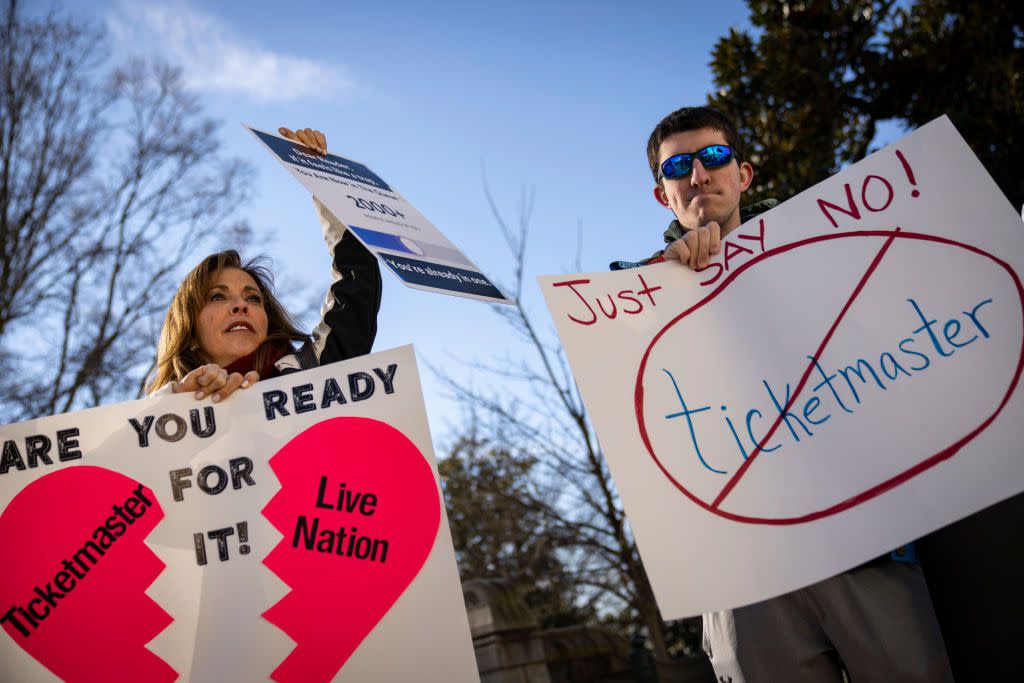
[{"left": 196, "top": 268, "right": 267, "bottom": 368}]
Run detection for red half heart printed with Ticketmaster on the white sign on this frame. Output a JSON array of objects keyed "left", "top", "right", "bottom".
[{"left": 0, "top": 465, "right": 177, "bottom": 683}]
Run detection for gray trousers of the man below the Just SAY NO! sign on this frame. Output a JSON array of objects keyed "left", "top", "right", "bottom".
[{"left": 703, "top": 561, "right": 953, "bottom": 683}]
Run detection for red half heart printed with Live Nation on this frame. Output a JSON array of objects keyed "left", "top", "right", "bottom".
[{"left": 263, "top": 418, "right": 440, "bottom": 682}]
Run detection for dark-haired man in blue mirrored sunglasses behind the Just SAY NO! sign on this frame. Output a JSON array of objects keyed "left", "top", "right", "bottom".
[{"left": 626, "top": 108, "right": 952, "bottom": 683}]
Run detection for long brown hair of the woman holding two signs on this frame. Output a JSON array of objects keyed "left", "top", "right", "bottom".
[{"left": 145, "top": 249, "right": 308, "bottom": 393}]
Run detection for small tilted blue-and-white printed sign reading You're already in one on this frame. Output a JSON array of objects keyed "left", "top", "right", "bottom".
[{"left": 246, "top": 126, "right": 512, "bottom": 303}]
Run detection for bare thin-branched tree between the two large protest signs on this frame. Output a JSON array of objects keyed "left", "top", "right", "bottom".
[{"left": 432, "top": 176, "right": 668, "bottom": 658}]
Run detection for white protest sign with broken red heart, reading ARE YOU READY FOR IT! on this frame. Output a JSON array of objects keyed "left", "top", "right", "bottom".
[{"left": 0, "top": 346, "right": 479, "bottom": 682}]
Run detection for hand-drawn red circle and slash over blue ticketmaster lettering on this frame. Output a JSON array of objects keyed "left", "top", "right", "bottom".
[{"left": 635, "top": 228, "right": 1024, "bottom": 524}]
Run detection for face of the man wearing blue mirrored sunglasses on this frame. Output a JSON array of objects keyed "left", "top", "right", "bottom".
[{"left": 654, "top": 128, "right": 754, "bottom": 236}]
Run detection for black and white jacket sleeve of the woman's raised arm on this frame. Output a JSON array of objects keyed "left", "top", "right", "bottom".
[{"left": 312, "top": 198, "right": 381, "bottom": 366}]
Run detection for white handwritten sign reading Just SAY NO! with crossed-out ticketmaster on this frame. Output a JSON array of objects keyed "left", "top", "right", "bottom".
[{"left": 540, "top": 118, "right": 1024, "bottom": 618}]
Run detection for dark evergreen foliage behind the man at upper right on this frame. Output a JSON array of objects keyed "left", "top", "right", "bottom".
[{"left": 709, "top": 0, "right": 1024, "bottom": 206}]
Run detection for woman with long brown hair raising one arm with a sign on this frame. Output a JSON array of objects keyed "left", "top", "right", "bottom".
[{"left": 147, "top": 128, "right": 381, "bottom": 402}]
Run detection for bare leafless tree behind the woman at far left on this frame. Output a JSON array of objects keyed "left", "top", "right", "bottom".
[{"left": 0, "top": 0, "right": 251, "bottom": 419}]
